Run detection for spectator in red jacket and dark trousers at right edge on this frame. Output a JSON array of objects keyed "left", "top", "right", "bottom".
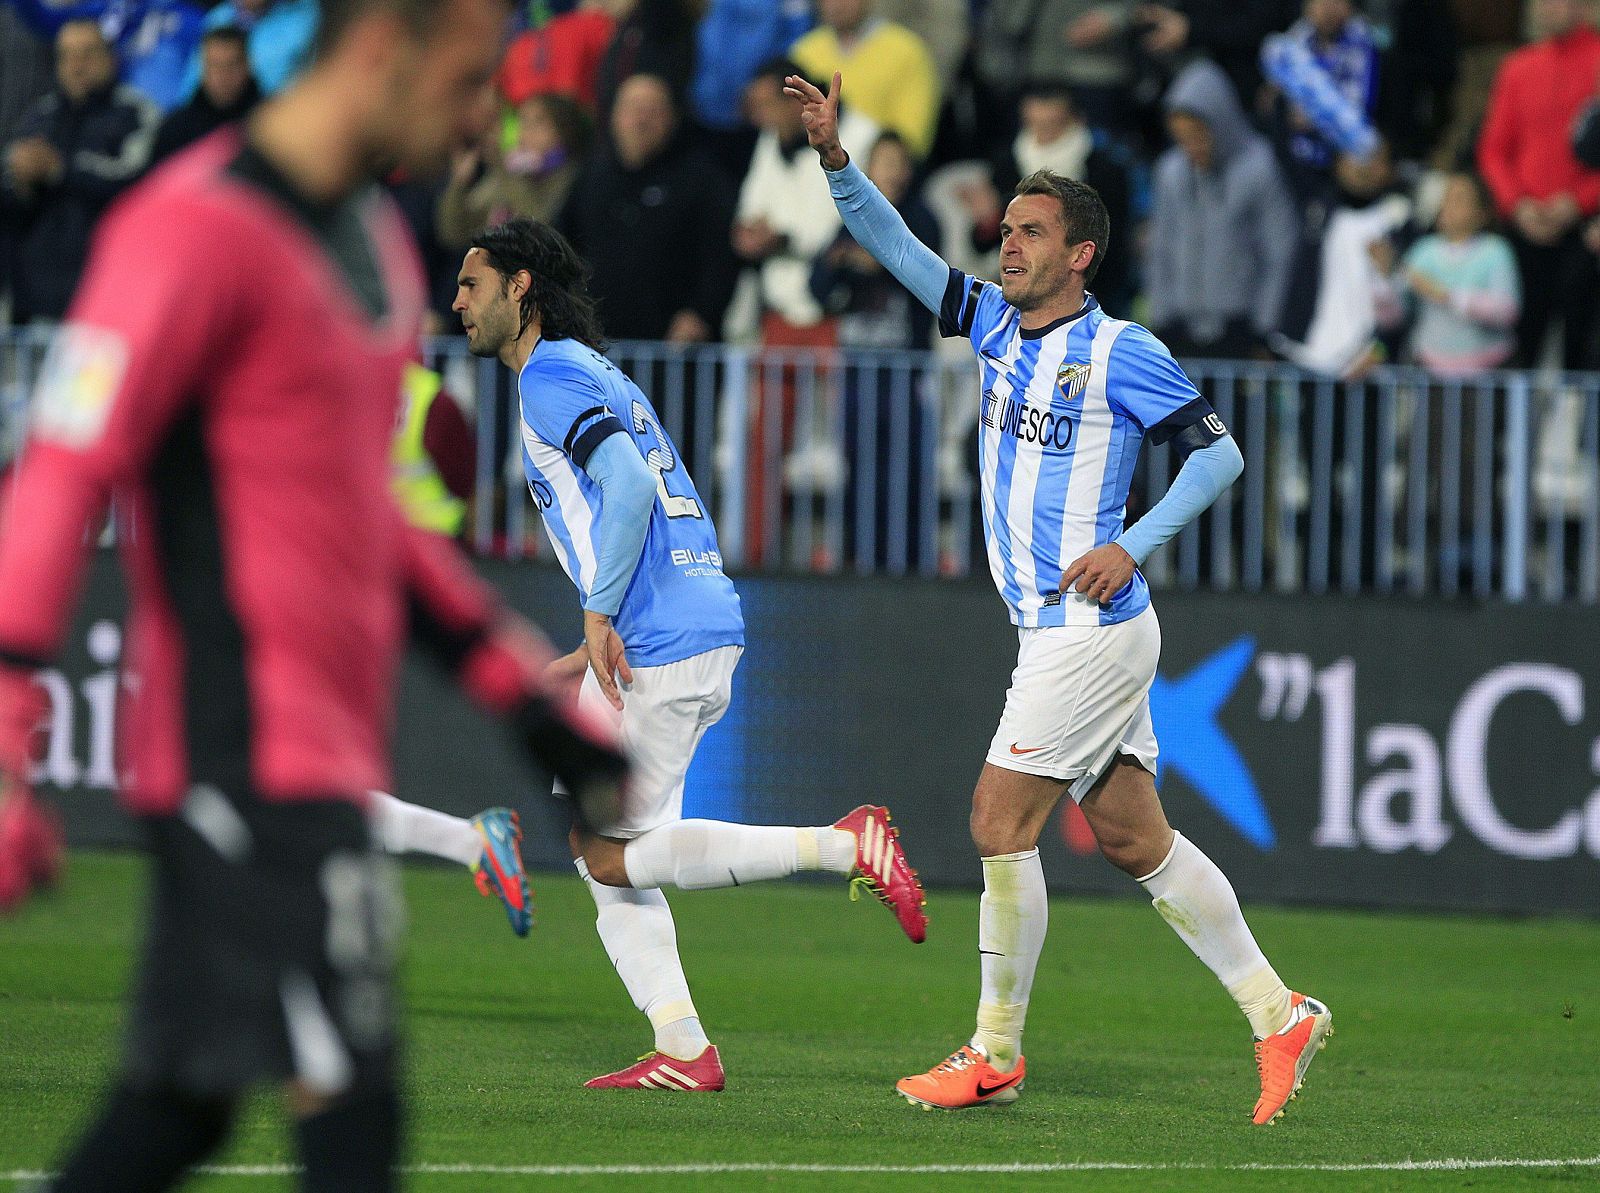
[{"left": 1478, "top": 0, "right": 1600, "bottom": 368}]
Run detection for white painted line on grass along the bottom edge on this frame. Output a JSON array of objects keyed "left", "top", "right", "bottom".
[{"left": 9, "top": 1156, "right": 1600, "bottom": 1182}]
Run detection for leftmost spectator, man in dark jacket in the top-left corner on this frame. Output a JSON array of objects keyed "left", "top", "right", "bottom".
[{"left": 0, "top": 21, "right": 160, "bottom": 323}]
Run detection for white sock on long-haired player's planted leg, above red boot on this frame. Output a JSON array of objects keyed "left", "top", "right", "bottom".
[{"left": 576, "top": 859, "right": 710, "bottom": 1060}]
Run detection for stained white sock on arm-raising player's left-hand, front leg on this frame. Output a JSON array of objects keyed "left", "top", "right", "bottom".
[{"left": 973, "top": 849, "right": 1050, "bottom": 1073}]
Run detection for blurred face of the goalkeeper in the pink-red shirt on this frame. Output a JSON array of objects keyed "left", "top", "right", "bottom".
[{"left": 382, "top": 0, "right": 506, "bottom": 176}]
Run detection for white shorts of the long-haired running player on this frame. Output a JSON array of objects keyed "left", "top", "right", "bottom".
[{"left": 555, "top": 646, "right": 744, "bottom": 840}]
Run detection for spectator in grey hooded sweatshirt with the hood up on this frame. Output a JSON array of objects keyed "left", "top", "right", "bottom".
[{"left": 1144, "top": 59, "right": 1298, "bottom": 357}]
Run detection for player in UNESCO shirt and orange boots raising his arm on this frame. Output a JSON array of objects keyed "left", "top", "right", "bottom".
[{"left": 786, "top": 75, "right": 1333, "bottom": 1123}]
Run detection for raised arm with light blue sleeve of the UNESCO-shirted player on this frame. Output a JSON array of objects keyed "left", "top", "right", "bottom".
[{"left": 784, "top": 74, "right": 950, "bottom": 315}]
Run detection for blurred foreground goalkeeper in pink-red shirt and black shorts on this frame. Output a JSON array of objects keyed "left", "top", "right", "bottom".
[{"left": 0, "top": 0, "right": 626, "bottom": 1193}]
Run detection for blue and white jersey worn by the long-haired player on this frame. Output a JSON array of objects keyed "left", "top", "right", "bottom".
[{"left": 517, "top": 339, "right": 744, "bottom": 667}]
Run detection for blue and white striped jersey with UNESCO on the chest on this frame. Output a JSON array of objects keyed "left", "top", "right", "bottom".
[{"left": 939, "top": 269, "right": 1214, "bottom": 627}]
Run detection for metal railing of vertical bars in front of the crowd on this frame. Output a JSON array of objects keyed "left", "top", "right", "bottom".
[{"left": 0, "top": 324, "right": 1600, "bottom": 603}]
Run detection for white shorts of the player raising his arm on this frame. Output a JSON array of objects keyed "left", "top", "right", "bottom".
[{"left": 989, "top": 608, "right": 1162, "bottom": 801}]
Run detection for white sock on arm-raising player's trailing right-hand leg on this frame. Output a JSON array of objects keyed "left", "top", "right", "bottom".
[{"left": 1139, "top": 833, "right": 1290, "bottom": 1036}]
